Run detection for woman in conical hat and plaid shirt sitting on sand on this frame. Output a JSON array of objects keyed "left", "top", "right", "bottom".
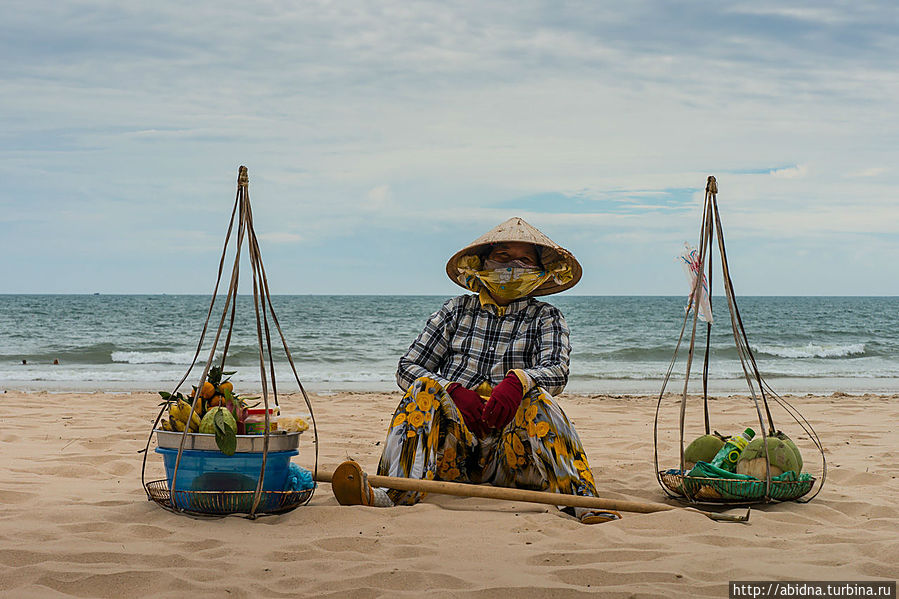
[{"left": 334, "top": 218, "right": 621, "bottom": 524}]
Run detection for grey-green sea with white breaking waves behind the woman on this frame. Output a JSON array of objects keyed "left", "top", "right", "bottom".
[{"left": 0, "top": 295, "right": 899, "bottom": 395}]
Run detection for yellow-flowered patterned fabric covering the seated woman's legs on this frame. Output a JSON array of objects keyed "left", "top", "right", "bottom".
[{"left": 378, "top": 377, "right": 597, "bottom": 505}]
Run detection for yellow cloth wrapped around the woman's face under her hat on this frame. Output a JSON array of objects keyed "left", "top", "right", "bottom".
[{"left": 457, "top": 256, "right": 571, "bottom": 302}]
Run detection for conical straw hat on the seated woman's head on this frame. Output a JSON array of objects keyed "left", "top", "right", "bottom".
[{"left": 446, "top": 216, "right": 583, "bottom": 295}]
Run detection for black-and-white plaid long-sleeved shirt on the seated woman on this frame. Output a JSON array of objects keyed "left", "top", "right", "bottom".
[{"left": 396, "top": 295, "right": 571, "bottom": 395}]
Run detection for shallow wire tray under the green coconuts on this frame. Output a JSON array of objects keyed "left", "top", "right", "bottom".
[{"left": 659, "top": 469, "right": 816, "bottom": 505}]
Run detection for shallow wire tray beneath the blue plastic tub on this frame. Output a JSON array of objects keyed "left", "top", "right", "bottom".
[{"left": 145, "top": 480, "right": 313, "bottom": 516}]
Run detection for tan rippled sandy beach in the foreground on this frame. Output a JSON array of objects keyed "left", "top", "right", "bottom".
[{"left": 0, "top": 392, "right": 899, "bottom": 598}]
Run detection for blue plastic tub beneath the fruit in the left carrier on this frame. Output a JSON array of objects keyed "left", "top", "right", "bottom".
[{"left": 156, "top": 447, "right": 299, "bottom": 491}]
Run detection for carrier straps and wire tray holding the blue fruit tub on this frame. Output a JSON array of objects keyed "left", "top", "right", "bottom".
[{"left": 141, "top": 166, "right": 318, "bottom": 519}]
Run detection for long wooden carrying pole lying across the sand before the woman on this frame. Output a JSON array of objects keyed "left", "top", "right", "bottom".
[{"left": 315, "top": 470, "right": 749, "bottom": 522}]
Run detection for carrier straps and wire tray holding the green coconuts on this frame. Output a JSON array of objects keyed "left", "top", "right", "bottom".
[{"left": 653, "top": 176, "right": 827, "bottom": 505}]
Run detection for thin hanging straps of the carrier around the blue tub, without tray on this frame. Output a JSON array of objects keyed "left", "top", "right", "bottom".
[{"left": 141, "top": 166, "right": 318, "bottom": 519}]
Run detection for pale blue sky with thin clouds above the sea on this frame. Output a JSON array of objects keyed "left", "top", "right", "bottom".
[{"left": 0, "top": 0, "right": 899, "bottom": 296}]
